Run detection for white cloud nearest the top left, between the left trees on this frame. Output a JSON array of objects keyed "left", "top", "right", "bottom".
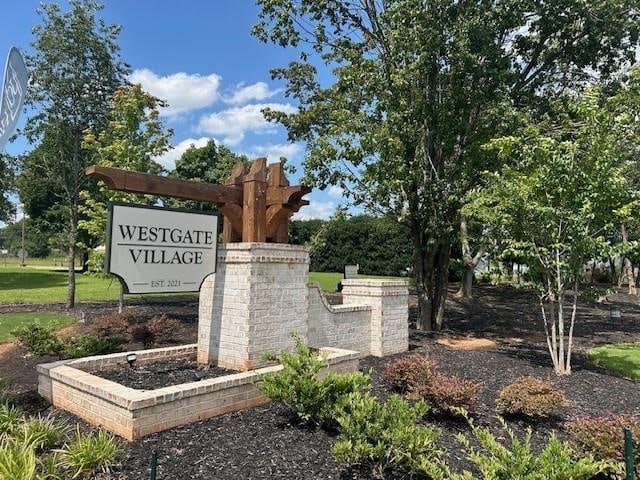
[{"left": 129, "top": 68, "right": 221, "bottom": 117}]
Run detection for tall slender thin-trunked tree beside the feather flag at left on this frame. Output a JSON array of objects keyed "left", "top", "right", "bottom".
[{"left": 26, "top": 0, "right": 128, "bottom": 308}]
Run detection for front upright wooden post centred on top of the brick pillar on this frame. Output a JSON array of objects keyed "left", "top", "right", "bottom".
[{"left": 242, "top": 158, "right": 267, "bottom": 242}]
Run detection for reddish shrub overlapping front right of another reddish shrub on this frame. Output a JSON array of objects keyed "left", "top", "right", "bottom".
[{"left": 410, "top": 374, "right": 482, "bottom": 415}]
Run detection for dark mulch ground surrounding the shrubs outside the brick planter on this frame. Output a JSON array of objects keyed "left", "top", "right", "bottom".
[{"left": 5, "top": 286, "right": 640, "bottom": 480}]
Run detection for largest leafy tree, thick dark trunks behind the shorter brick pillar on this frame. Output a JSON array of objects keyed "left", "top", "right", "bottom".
[{"left": 254, "top": 0, "right": 640, "bottom": 329}]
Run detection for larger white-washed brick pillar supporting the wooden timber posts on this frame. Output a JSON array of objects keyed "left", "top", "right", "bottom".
[{"left": 198, "top": 243, "right": 309, "bottom": 370}]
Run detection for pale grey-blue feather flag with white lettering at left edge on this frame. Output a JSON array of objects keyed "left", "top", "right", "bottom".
[{"left": 0, "top": 47, "right": 29, "bottom": 150}]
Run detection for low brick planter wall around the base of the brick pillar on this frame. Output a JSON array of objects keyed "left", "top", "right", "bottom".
[{"left": 37, "top": 345, "right": 358, "bottom": 440}]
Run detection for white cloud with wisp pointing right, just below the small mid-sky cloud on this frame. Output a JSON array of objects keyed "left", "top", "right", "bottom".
[{"left": 198, "top": 103, "right": 296, "bottom": 146}]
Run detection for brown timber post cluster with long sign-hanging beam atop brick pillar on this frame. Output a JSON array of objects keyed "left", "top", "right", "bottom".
[{"left": 86, "top": 158, "right": 311, "bottom": 243}]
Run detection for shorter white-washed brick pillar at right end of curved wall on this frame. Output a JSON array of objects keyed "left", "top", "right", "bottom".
[{"left": 342, "top": 279, "right": 409, "bottom": 357}]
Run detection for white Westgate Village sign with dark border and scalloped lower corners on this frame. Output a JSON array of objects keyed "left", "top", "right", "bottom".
[{"left": 106, "top": 203, "right": 218, "bottom": 293}]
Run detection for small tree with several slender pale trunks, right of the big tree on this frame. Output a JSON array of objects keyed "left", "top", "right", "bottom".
[{"left": 466, "top": 87, "right": 635, "bottom": 375}]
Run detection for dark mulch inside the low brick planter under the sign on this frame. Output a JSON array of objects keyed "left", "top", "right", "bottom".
[{"left": 92, "top": 358, "right": 238, "bottom": 390}]
